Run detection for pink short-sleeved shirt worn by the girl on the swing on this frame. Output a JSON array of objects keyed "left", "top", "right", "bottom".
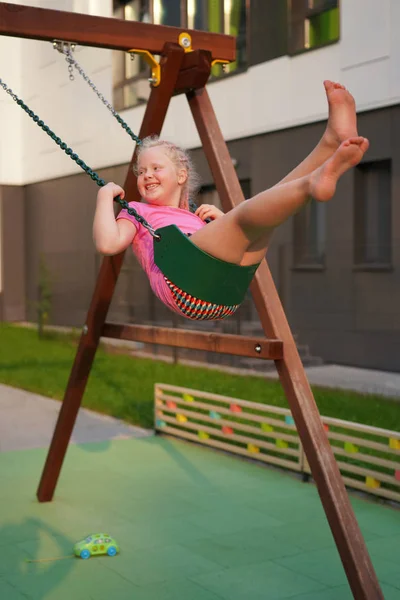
[{"left": 117, "top": 202, "right": 206, "bottom": 314}]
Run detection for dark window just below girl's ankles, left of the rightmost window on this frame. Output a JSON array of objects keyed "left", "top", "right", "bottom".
[{"left": 293, "top": 199, "right": 326, "bottom": 268}]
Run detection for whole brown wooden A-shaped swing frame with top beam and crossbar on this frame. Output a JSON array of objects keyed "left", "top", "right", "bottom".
[{"left": 0, "top": 2, "right": 383, "bottom": 600}]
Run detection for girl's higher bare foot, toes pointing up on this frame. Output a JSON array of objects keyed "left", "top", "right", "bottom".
[{"left": 323, "top": 80, "right": 358, "bottom": 149}]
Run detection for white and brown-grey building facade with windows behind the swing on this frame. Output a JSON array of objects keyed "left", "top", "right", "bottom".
[{"left": 0, "top": 0, "right": 400, "bottom": 371}]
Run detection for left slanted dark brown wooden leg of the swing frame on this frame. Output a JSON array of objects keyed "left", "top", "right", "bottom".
[{"left": 37, "top": 44, "right": 184, "bottom": 502}]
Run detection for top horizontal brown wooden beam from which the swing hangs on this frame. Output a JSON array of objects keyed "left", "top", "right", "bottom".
[{"left": 0, "top": 2, "right": 236, "bottom": 61}]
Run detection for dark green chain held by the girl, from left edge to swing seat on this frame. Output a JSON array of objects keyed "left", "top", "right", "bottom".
[{"left": 0, "top": 79, "right": 160, "bottom": 240}]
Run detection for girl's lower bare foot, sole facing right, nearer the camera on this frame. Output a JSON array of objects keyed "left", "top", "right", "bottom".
[{"left": 309, "top": 137, "right": 369, "bottom": 202}]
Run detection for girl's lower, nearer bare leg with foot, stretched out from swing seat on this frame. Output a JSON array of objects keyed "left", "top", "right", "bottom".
[{"left": 191, "top": 137, "right": 369, "bottom": 265}]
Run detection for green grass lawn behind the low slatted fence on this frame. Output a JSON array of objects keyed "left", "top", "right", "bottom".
[{"left": 0, "top": 323, "right": 399, "bottom": 430}]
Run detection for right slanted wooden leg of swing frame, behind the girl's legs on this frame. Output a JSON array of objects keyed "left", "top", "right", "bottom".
[{"left": 187, "top": 88, "right": 383, "bottom": 600}]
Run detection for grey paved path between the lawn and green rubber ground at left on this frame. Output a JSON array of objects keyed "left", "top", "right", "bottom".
[{"left": 0, "top": 384, "right": 152, "bottom": 452}]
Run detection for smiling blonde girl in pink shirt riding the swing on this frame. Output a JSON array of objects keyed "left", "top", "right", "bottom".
[{"left": 93, "top": 81, "right": 369, "bottom": 319}]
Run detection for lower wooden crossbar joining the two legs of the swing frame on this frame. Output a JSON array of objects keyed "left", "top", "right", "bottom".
[{"left": 101, "top": 323, "right": 283, "bottom": 360}]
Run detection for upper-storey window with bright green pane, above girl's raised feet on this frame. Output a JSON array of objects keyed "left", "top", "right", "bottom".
[{"left": 289, "top": 0, "right": 340, "bottom": 54}]
